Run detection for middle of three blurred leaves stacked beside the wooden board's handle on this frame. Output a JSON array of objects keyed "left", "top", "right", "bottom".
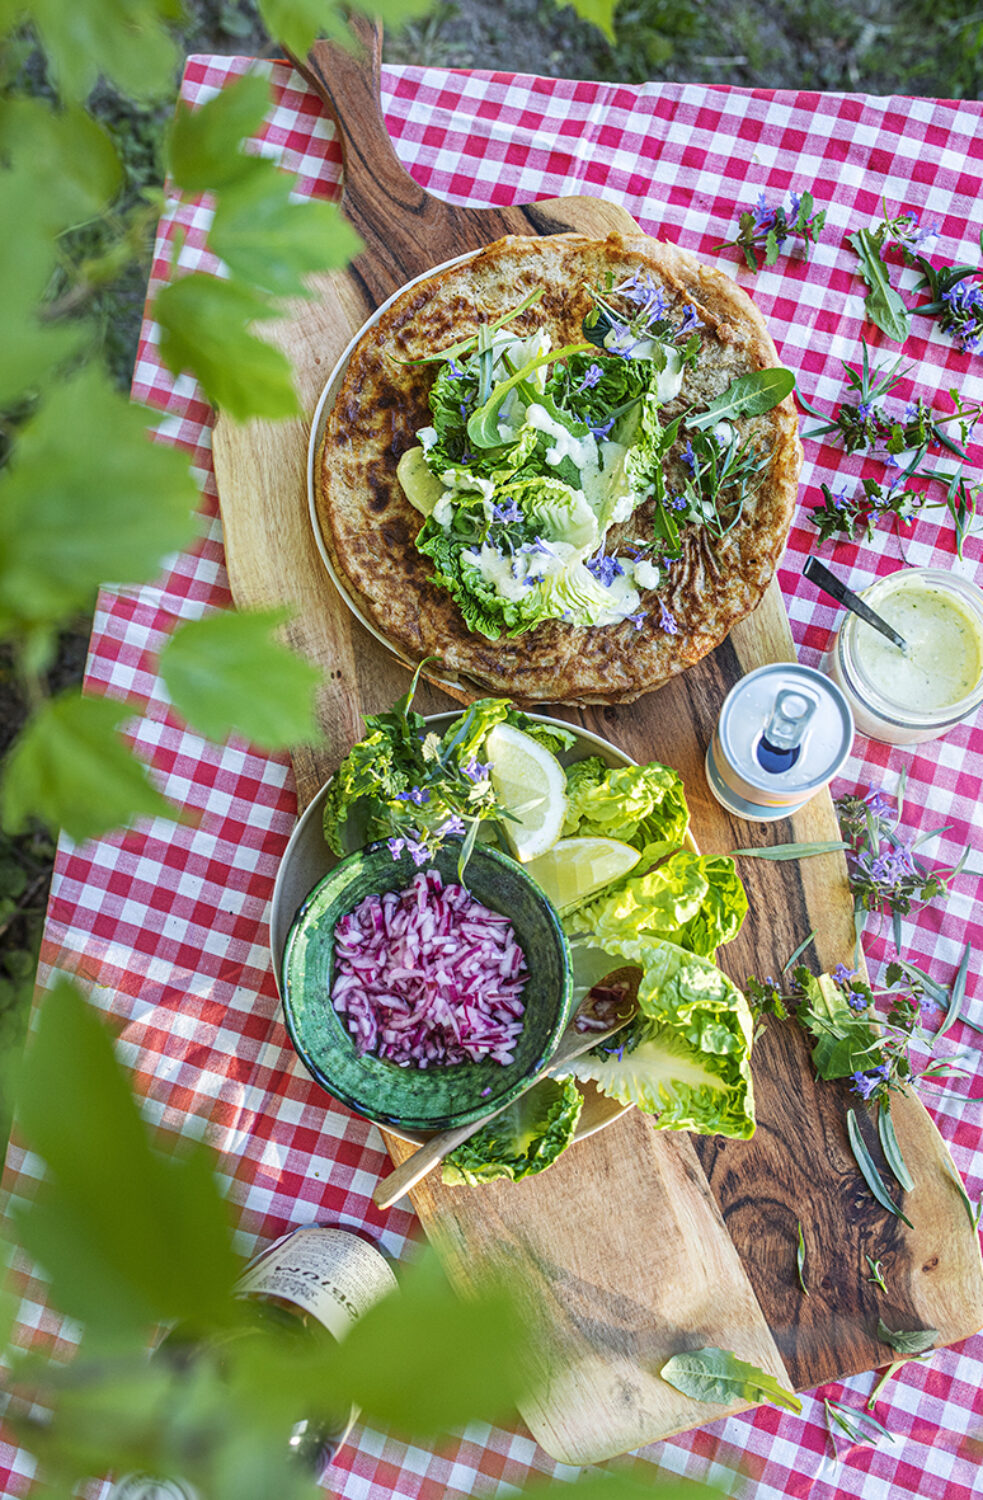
[{"left": 209, "top": 161, "right": 362, "bottom": 297}]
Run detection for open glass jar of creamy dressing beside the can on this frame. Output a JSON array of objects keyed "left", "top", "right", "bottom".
[{"left": 822, "top": 567, "right": 983, "bottom": 746}]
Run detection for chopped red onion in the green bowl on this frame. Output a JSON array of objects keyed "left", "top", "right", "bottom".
[{"left": 332, "top": 870, "right": 527, "bottom": 1068}]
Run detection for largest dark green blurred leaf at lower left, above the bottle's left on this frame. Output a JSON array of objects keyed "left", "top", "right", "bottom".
[{"left": 17, "top": 978, "right": 240, "bottom": 1343}]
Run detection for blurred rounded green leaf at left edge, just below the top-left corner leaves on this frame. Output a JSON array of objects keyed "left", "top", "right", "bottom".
[{"left": 0, "top": 96, "right": 123, "bottom": 230}]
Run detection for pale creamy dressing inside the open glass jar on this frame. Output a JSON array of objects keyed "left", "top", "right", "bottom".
[{"left": 855, "top": 572, "right": 983, "bottom": 713}]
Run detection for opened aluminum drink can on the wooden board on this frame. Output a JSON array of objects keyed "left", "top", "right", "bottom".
[{"left": 707, "top": 662, "right": 854, "bottom": 822}]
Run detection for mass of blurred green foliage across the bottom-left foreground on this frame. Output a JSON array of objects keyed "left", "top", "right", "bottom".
[{"left": 0, "top": 978, "right": 729, "bottom": 1500}]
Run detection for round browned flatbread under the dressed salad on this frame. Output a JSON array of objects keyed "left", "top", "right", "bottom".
[{"left": 317, "top": 234, "right": 801, "bottom": 705}]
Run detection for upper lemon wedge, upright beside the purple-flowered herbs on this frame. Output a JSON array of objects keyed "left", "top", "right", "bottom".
[{"left": 483, "top": 725, "right": 567, "bottom": 863}]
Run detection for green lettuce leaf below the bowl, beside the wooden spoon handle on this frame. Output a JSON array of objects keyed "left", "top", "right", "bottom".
[{"left": 443, "top": 1079, "right": 584, "bottom": 1188}]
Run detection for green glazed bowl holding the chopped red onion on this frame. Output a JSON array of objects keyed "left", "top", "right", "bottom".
[{"left": 282, "top": 839, "right": 573, "bottom": 1131}]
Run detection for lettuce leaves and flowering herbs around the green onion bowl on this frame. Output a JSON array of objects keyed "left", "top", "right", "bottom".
[{"left": 324, "top": 672, "right": 755, "bottom": 1185}]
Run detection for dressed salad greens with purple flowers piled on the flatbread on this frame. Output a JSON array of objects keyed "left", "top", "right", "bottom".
[{"left": 398, "top": 272, "right": 794, "bottom": 641}]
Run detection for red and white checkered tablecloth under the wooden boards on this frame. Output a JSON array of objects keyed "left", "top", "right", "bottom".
[{"left": 0, "top": 57, "right": 983, "bottom": 1500}]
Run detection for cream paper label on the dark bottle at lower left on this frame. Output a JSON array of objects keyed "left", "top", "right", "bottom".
[{"left": 237, "top": 1224, "right": 396, "bottom": 1338}]
